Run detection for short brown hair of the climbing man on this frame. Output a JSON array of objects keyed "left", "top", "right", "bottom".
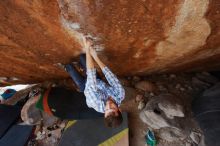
[{"left": 104, "top": 110, "right": 123, "bottom": 128}]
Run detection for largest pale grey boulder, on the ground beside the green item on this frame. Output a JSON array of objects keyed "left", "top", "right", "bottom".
[{"left": 140, "top": 94, "right": 190, "bottom": 142}]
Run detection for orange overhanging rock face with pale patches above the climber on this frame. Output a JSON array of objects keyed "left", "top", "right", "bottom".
[{"left": 0, "top": 0, "right": 220, "bottom": 83}]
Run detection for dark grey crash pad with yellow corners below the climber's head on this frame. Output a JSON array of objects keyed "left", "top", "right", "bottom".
[{"left": 59, "top": 113, "right": 129, "bottom": 146}]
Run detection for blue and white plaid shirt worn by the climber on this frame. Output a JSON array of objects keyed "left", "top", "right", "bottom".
[{"left": 84, "top": 67, "right": 125, "bottom": 113}]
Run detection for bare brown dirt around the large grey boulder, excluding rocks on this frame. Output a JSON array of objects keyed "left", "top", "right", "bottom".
[{"left": 122, "top": 73, "right": 211, "bottom": 146}]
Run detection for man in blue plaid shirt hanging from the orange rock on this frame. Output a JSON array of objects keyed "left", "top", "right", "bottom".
[{"left": 62, "top": 38, "right": 125, "bottom": 127}]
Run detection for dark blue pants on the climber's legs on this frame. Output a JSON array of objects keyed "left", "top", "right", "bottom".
[{"left": 65, "top": 54, "right": 86, "bottom": 92}]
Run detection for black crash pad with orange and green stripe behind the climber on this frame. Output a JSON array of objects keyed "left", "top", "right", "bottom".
[{"left": 36, "top": 87, "right": 104, "bottom": 120}]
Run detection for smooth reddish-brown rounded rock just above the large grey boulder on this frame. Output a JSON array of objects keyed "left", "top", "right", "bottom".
[{"left": 135, "top": 81, "right": 156, "bottom": 92}]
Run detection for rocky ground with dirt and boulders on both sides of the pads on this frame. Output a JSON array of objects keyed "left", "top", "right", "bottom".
[{"left": 3, "top": 72, "right": 218, "bottom": 146}]
